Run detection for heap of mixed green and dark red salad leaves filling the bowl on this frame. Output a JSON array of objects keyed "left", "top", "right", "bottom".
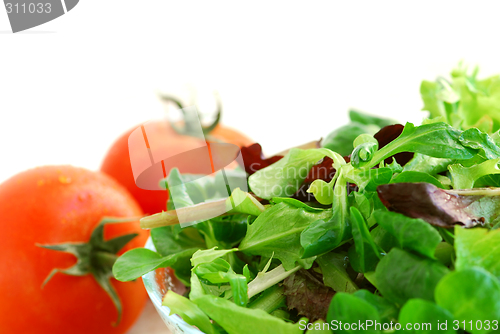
[{"left": 113, "top": 67, "right": 500, "bottom": 334}]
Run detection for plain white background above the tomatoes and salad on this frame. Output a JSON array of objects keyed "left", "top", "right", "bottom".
[{"left": 0, "top": 0, "right": 500, "bottom": 182}]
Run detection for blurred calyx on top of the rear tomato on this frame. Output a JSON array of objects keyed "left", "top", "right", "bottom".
[{"left": 160, "top": 95, "right": 222, "bottom": 140}]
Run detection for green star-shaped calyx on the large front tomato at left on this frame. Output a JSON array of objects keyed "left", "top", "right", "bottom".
[{"left": 37, "top": 217, "right": 139, "bottom": 326}]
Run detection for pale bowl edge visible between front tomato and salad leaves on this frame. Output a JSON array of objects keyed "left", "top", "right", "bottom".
[{"left": 142, "top": 238, "right": 203, "bottom": 334}]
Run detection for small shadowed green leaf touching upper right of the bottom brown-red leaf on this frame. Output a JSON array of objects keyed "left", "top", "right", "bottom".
[{"left": 316, "top": 252, "right": 358, "bottom": 293}]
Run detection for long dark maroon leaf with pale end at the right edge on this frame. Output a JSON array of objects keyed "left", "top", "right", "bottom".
[{"left": 377, "top": 183, "right": 494, "bottom": 228}]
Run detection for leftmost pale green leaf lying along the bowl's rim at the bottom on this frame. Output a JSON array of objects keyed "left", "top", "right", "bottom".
[{"left": 162, "top": 291, "right": 220, "bottom": 334}]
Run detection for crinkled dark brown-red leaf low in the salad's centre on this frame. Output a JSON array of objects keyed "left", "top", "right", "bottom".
[{"left": 283, "top": 269, "right": 335, "bottom": 322}]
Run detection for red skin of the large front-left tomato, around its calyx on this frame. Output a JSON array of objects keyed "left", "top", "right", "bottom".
[{"left": 0, "top": 166, "right": 148, "bottom": 334}]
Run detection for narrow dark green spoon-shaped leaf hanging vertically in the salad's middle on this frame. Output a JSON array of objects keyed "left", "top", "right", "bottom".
[{"left": 349, "top": 207, "right": 383, "bottom": 273}]
